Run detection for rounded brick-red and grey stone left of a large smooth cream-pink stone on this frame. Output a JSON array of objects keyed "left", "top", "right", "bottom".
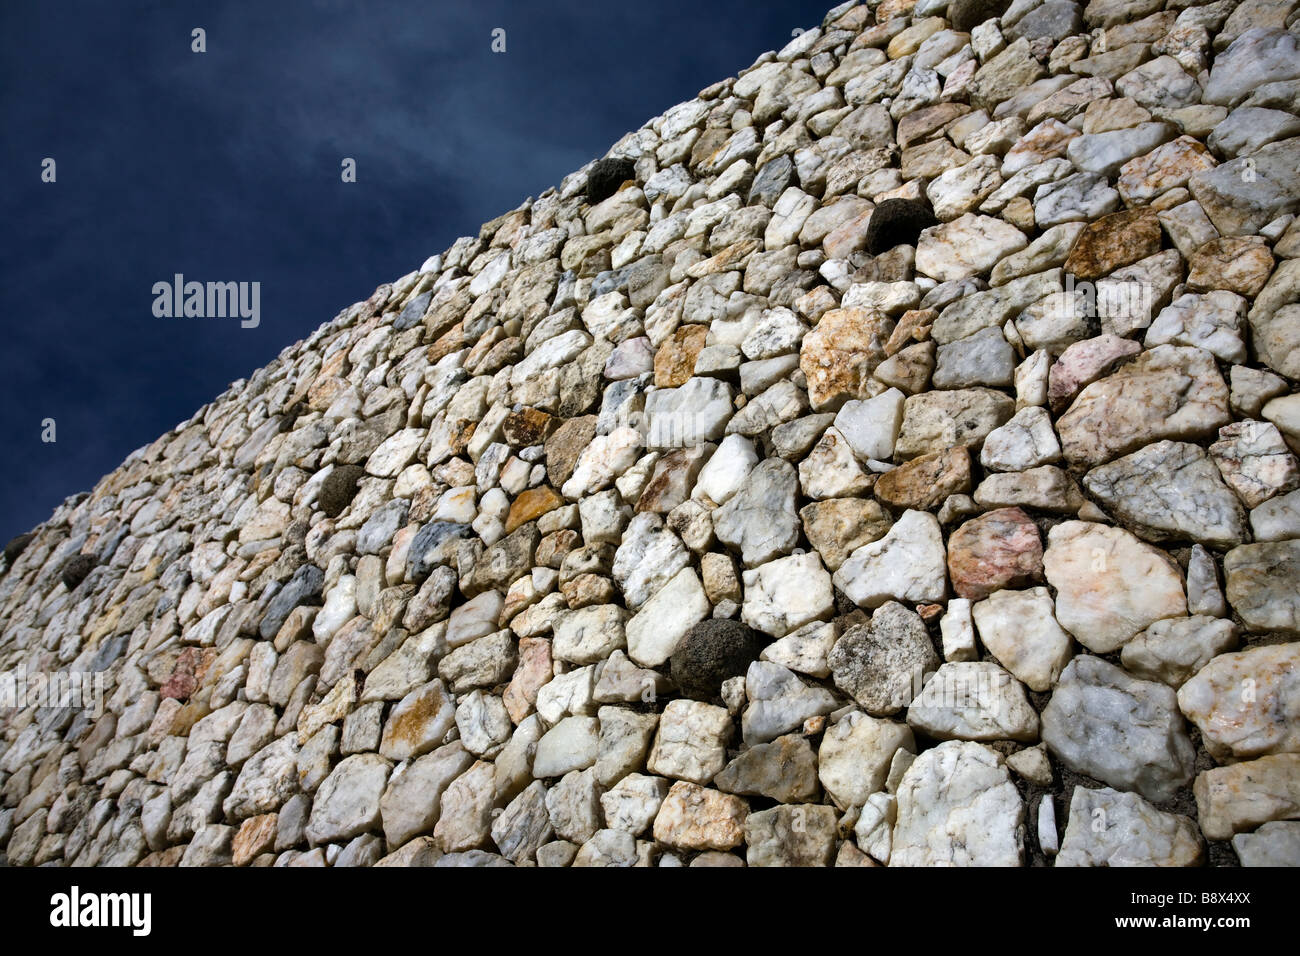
[{"left": 948, "top": 507, "right": 1043, "bottom": 601}]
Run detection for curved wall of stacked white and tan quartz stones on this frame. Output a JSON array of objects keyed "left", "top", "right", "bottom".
[{"left": 0, "top": 0, "right": 1300, "bottom": 866}]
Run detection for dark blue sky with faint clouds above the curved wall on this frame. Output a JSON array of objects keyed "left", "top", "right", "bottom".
[{"left": 0, "top": 0, "right": 832, "bottom": 544}]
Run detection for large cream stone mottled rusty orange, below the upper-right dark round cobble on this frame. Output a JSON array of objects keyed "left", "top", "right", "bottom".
[{"left": 800, "top": 308, "right": 894, "bottom": 411}]
